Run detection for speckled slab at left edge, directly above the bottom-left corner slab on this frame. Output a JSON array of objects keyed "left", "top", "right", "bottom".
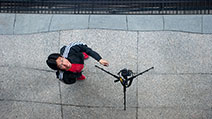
[{"left": 0, "top": 67, "right": 60, "bottom": 103}]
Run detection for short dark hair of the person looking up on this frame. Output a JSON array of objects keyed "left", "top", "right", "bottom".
[{"left": 46, "top": 53, "right": 62, "bottom": 70}]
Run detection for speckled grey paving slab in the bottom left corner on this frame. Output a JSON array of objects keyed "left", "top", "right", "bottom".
[{"left": 0, "top": 101, "right": 62, "bottom": 119}]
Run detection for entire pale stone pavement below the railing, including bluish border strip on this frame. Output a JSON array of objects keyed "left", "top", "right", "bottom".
[{"left": 0, "top": 14, "right": 212, "bottom": 119}]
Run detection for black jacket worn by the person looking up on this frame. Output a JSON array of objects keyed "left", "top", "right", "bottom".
[{"left": 56, "top": 44, "right": 102, "bottom": 84}]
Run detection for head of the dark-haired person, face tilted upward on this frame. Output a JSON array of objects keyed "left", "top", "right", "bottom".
[{"left": 46, "top": 53, "right": 71, "bottom": 70}]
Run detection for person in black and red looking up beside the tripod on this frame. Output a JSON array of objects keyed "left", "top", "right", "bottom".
[{"left": 46, "top": 42, "right": 109, "bottom": 84}]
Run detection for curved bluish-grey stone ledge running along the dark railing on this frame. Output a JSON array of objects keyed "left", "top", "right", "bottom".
[{"left": 0, "top": 14, "right": 212, "bottom": 35}]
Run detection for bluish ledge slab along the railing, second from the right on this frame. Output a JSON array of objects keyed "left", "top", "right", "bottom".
[{"left": 164, "top": 15, "right": 202, "bottom": 33}]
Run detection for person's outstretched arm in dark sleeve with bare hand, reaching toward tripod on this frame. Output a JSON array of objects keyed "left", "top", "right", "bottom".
[{"left": 79, "top": 45, "right": 109, "bottom": 66}]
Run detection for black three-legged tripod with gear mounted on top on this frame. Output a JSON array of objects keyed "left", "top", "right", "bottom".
[{"left": 95, "top": 65, "right": 154, "bottom": 110}]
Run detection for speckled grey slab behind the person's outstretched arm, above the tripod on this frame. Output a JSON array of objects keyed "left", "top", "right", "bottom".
[{"left": 60, "top": 30, "right": 137, "bottom": 73}]
